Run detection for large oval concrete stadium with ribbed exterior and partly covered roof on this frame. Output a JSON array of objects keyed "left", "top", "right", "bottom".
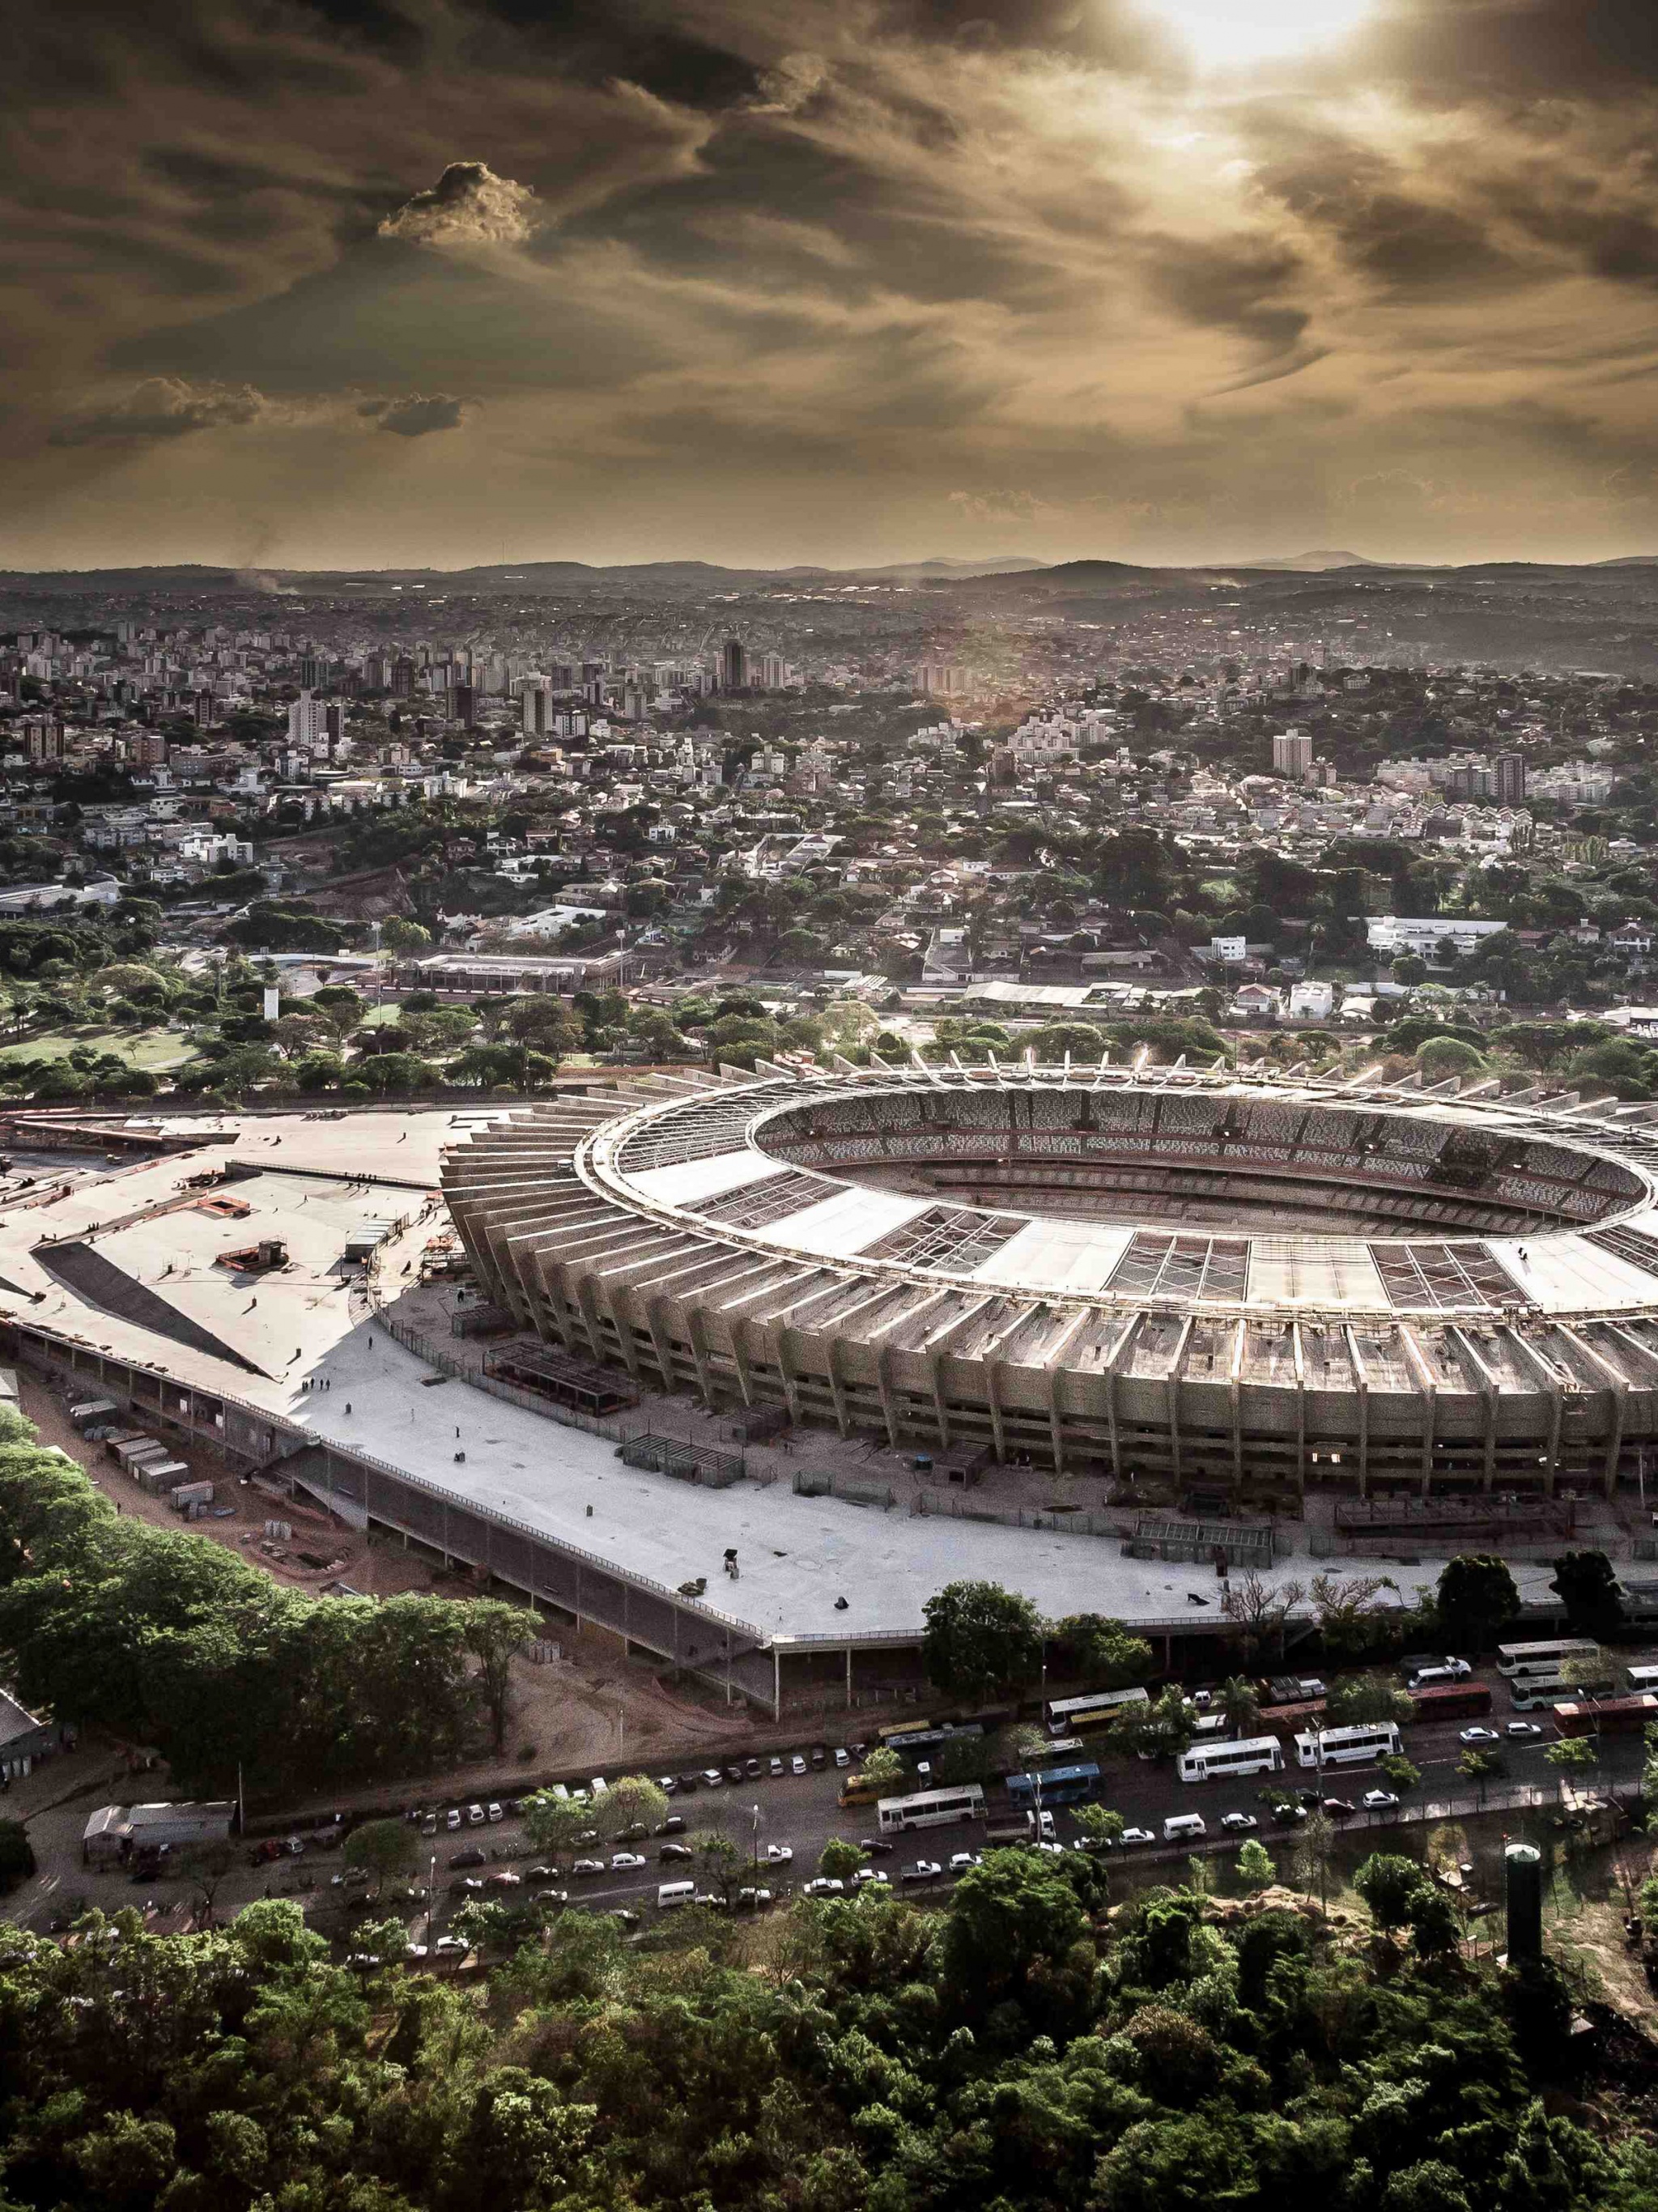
[{"left": 444, "top": 1061, "right": 1658, "bottom": 1515}]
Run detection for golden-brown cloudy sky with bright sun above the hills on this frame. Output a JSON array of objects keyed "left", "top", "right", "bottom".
[{"left": 0, "top": 0, "right": 1658, "bottom": 568}]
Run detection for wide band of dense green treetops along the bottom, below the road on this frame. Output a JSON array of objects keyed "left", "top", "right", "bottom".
[{"left": 0, "top": 1852, "right": 1658, "bottom": 2212}]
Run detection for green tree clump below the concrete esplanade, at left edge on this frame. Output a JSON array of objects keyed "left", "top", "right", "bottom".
[{"left": 0, "top": 1414, "right": 538, "bottom": 1794}]
